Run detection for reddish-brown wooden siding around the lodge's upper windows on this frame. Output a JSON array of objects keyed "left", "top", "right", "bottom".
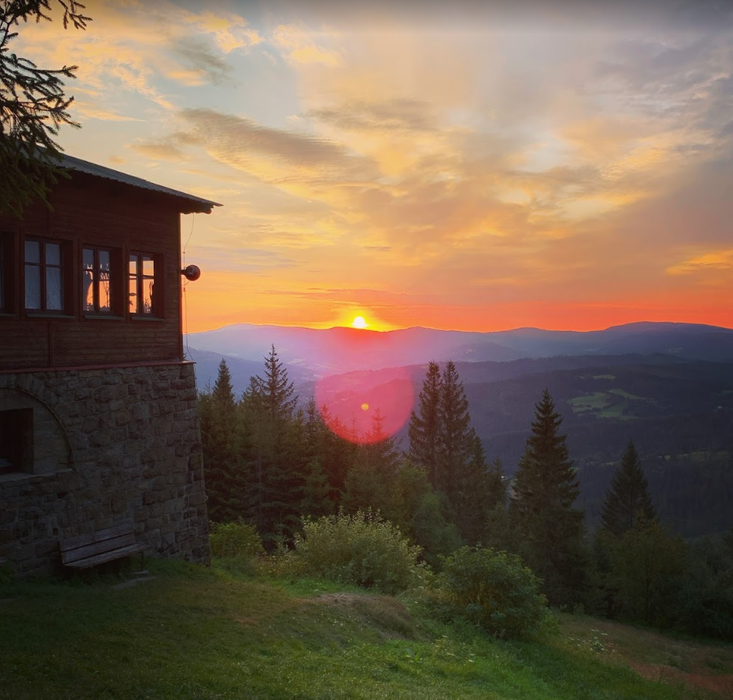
[{"left": 0, "top": 173, "right": 183, "bottom": 370}]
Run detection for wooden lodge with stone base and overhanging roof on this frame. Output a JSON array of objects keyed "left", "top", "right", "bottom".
[{"left": 0, "top": 156, "right": 218, "bottom": 574}]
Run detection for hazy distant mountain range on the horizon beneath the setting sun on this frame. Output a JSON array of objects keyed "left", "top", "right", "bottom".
[{"left": 186, "top": 322, "right": 733, "bottom": 390}]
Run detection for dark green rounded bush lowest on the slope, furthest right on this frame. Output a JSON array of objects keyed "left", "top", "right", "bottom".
[{"left": 436, "top": 546, "right": 547, "bottom": 637}]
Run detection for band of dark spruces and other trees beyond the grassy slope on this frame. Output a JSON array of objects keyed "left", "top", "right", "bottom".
[{"left": 199, "top": 347, "right": 733, "bottom": 638}]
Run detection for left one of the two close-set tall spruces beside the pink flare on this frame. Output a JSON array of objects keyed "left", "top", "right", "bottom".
[{"left": 408, "top": 362, "right": 442, "bottom": 488}]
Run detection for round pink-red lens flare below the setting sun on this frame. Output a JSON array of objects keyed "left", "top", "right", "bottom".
[{"left": 315, "top": 369, "right": 415, "bottom": 445}]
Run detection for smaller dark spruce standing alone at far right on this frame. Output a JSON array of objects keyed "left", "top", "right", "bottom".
[{"left": 602, "top": 440, "right": 657, "bottom": 537}]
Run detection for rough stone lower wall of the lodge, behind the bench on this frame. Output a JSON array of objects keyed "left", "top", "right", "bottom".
[{"left": 0, "top": 362, "right": 209, "bottom": 575}]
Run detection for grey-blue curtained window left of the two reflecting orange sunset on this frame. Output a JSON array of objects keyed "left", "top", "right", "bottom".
[{"left": 25, "top": 239, "right": 64, "bottom": 311}]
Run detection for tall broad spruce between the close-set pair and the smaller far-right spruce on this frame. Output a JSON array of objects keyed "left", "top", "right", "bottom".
[{"left": 510, "top": 389, "right": 585, "bottom": 605}]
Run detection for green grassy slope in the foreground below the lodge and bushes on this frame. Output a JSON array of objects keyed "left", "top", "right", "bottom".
[{"left": 0, "top": 562, "right": 733, "bottom": 700}]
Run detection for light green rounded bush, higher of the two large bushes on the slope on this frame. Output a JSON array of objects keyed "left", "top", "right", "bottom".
[{"left": 295, "top": 511, "right": 422, "bottom": 593}]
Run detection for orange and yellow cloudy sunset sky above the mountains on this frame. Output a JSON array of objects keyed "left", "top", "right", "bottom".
[{"left": 11, "top": 0, "right": 733, "bottom": 331}]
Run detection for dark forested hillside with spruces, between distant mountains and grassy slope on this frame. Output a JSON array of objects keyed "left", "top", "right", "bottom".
[{"left": 200, "top": 347, "right": 733, "bottom": 637}]
